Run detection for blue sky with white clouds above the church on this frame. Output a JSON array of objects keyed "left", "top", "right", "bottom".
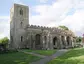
[{"left": 0, "top": 0, "right": 84, "bottom": 38}]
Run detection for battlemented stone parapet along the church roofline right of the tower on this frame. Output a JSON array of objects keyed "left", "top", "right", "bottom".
[{"left": 26, "top": 25, "right": 73, "bottom": 35}]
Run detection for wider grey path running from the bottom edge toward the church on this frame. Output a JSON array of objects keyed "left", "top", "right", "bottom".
[{"left": 30, "top": 49, "right": 68, "bottom": 64}]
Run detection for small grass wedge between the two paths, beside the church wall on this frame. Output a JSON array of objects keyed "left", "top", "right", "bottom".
[{"left": 23, "top": 49, "right": 56, "bottom": 56}]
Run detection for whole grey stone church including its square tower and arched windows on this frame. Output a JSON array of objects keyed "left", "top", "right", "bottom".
[{"left": 9, "top": 4, "right": 75, "bottom": 50}]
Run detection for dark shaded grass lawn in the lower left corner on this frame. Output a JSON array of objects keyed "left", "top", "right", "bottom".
[{"left": 0, "top": 52, "right": 40, "bottom": 64}]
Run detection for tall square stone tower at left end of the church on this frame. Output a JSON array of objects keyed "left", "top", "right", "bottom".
[{"left": 10, "top": 4, "right": 29, "bottom": 49}]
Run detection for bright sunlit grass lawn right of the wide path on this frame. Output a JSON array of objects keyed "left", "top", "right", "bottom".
[{"left": 48, "top": 48, "right": 84, "bottom": 64}]
